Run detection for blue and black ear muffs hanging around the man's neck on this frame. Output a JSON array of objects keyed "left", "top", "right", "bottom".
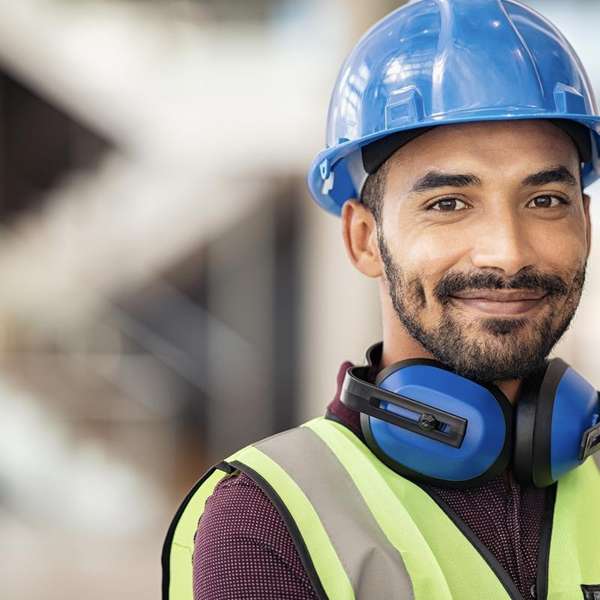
[{"left": 341, "top": 343, "right": 600, "bottom": 487}]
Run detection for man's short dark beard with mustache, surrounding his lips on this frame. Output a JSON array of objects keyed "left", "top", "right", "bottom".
[{"left": 378, "top": 229, "right": 586, "bottom": 383}]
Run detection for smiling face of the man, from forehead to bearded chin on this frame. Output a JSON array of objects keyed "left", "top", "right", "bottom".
[{"left": 377, "top": 121, "right": 590, "bottom": 382}]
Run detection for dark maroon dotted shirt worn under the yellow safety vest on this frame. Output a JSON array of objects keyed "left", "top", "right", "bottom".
[{"left": 194, "top": 362, "right": 546, "bottom": 600}]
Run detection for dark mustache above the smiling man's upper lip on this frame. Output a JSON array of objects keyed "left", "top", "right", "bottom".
[{"left": 433, "top": 267, "right": 569, "bottom": 302}]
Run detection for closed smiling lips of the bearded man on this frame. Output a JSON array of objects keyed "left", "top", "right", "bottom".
[{"left": 450, "top": 290, "right": 547, "bottom": 316}]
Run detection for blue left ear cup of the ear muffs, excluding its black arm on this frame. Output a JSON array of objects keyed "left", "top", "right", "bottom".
[{"left": 361, "top": 360, "right": 512, "bottom": 488}]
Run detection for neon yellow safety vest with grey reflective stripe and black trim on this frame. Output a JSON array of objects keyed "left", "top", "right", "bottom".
[{"left": 163, "top": 417, "right": 600, "bottom": 600}]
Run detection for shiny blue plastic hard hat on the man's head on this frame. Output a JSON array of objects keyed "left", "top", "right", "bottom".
[{"left": 308, "top": 0, "right": 600, "bottom": 215}]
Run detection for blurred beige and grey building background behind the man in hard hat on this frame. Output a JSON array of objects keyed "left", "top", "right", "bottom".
[{"left": 0, "top": 0, "right": 600, "bottom": 600}]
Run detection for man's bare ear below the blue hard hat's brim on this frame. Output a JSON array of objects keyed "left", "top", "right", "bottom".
[{"left": 342, "top": 200, "right": 383, "bottom": 277}]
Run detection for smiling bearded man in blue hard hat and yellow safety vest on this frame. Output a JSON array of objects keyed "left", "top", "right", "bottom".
[{"left": 163, "top": 0, "right": 600, "bottom": 600}]
